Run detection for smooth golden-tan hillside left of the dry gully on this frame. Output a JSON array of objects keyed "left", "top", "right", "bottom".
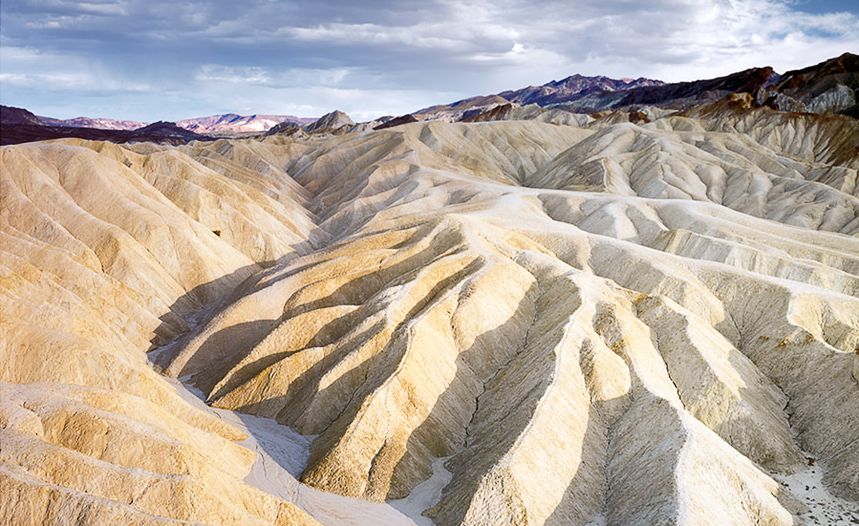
[{"left": 0, "top": 142, "right": 320, "bottom": 525}]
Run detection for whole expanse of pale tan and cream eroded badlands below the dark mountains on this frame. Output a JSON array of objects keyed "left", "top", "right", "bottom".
[{"left": 0, "top": 96, "right": 859, "bottom": 526}]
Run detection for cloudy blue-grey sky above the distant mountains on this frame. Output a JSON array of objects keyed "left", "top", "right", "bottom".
[{"left": 0, "top": 0, "right": 859, "bottom": 122}]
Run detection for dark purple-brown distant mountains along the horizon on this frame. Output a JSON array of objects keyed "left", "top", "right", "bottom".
[{"left": 2, "top": 53, "right": 859, "bottom": 144}]
